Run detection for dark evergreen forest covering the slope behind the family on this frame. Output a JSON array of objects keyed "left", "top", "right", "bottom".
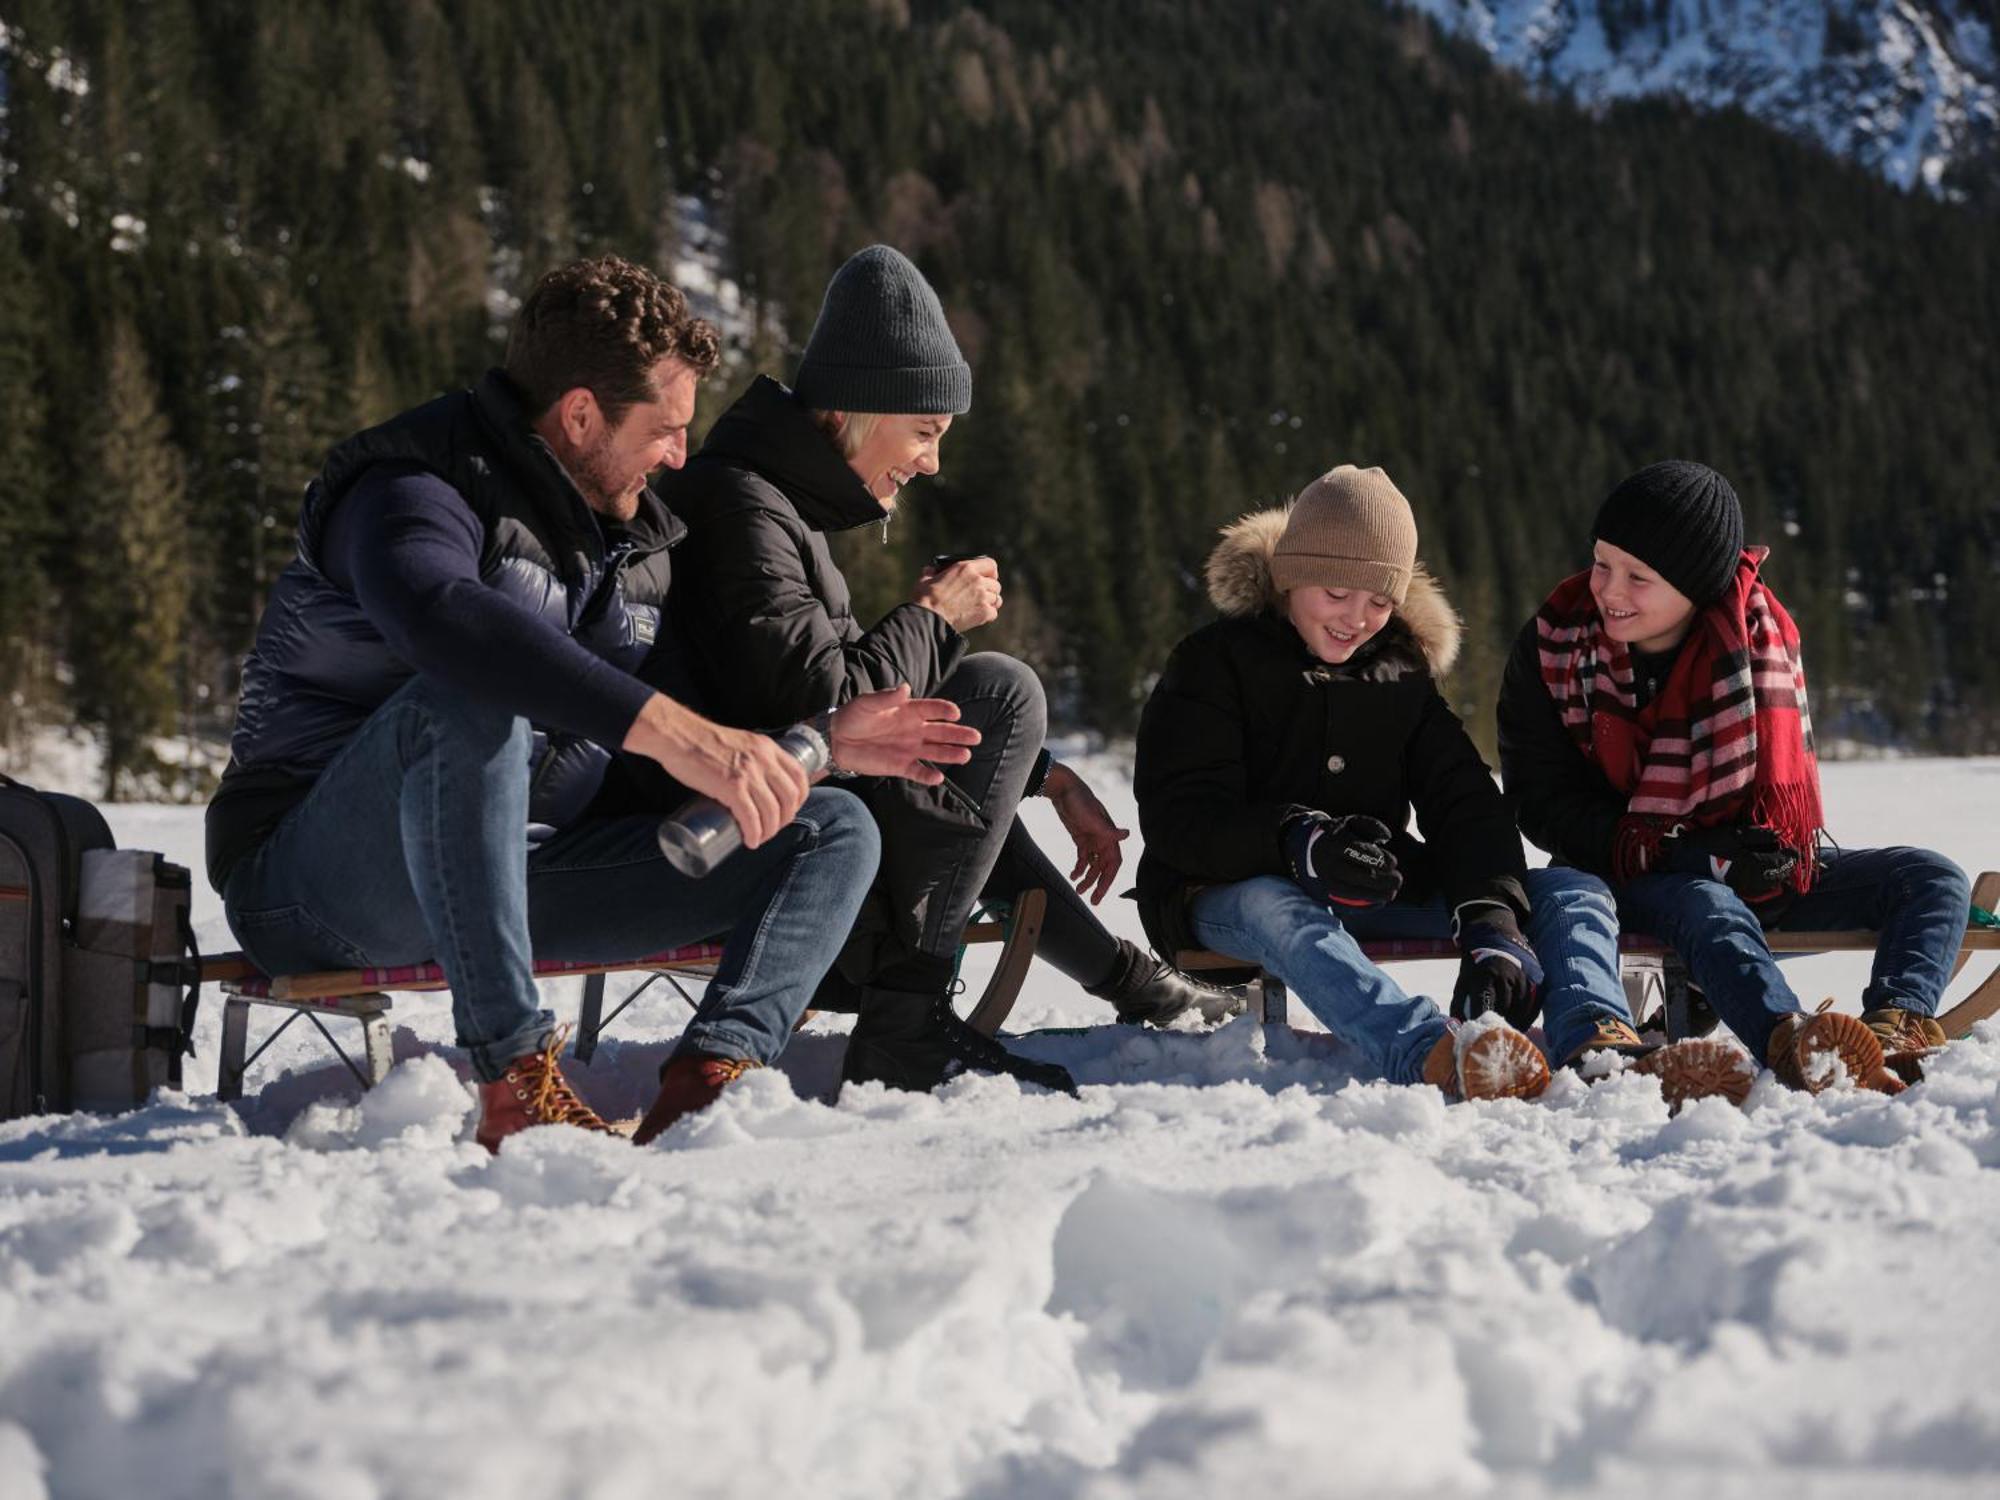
[{"left": 0, "top": 0, "right": 2000, "bottom": 794}]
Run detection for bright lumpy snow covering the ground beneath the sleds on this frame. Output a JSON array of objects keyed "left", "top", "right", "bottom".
[{"left": 0, "top": 758, "right": 2000, "bottom": 1500}]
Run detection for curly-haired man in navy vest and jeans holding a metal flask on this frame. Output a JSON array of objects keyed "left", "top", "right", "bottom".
[{"left": 208, "top": 258, "right": 978, "bottom": 1150}]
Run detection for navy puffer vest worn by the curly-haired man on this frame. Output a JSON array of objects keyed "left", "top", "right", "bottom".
[{"left": 208, "top": 370, "right": 686, "bottom": 888}]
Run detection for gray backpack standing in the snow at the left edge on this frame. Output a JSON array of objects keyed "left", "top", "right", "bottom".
[{"left": 0, "top": 776, "right": 202, "bottom": 1120}]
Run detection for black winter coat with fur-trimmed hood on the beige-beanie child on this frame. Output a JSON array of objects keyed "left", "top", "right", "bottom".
[{"left": 1134, "top": 510, "right": 1528, "bottom": 954}]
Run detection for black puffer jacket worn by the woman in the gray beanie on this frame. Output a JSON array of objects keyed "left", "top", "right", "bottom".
[{"left": 660, "top": 376, "right": 966, "bottom": 728}]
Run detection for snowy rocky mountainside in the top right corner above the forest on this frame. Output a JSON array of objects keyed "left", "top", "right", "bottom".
[{"left": 1404, "top": 0, "right": 2000, "bottom": 190}]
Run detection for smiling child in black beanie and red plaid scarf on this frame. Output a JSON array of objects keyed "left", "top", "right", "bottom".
[{"left": 1500, "top": 460, "right": 1970, "bottom": 1094}]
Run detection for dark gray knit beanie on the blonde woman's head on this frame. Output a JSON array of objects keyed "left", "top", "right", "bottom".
[{"left": 792, "top": 244, "right": 972, "bottom": 416}]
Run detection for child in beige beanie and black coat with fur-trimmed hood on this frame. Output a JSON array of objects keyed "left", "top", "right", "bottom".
[{"left": 1138, "top": 464, "right": 1732, "bottom": 1104}]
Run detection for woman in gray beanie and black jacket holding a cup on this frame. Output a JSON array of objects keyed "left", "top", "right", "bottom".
[{"left": 662, "top": 246, "right": 1240, "bottom": 1088}]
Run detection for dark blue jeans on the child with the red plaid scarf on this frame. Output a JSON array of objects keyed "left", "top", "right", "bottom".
[{"left": 1618, "top": 848, "right": 1972, "bottom": 1060}]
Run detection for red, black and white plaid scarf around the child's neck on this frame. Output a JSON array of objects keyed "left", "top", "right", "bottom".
[{"left": 1534, "top": 548, "right": 1822, "bottom": 890}]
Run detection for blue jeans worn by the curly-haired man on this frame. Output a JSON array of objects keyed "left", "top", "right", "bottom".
[{"left": 222, "top": 678, "right": 880, "bottom": 1082}]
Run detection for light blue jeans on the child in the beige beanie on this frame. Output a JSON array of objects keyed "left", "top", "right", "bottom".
[{"left": 1188, "top": 870, "right": 1632, "bottom": 1084}]
